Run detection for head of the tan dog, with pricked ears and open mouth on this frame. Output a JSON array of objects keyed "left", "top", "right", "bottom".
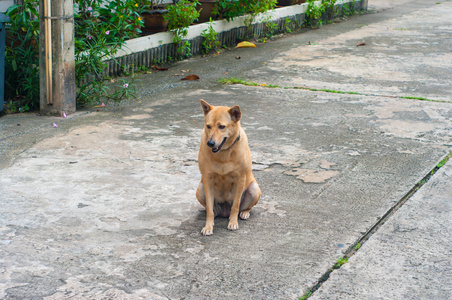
[{"left": 201, "top": 100, "right": 242, "bottom": 153}]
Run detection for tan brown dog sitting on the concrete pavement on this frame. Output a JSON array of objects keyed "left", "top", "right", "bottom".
[{"left": 196, "top": 100, "right": 261, "bottom": 235}]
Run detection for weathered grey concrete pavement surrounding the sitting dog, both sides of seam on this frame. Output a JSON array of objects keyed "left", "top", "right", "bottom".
[{"left": 0, "top": 0, "right": 452, "bottom": 299}]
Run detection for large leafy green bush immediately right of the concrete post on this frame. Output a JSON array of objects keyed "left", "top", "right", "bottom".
[{"left": 74, "top": 0, "right": 142, "bottom": 105}]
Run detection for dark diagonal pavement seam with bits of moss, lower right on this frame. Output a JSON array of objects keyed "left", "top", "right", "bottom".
[{"left": 300, "top": 150, "right": 452, "bottom": 300}]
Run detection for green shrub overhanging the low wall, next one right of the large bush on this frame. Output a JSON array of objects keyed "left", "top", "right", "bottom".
[{"left": 164, "top": 0, "right": 199, "bottom": 56}]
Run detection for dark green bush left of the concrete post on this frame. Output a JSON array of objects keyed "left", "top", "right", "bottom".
[{"left": 5, "top": 0, "right": 39, "bottom": 112}]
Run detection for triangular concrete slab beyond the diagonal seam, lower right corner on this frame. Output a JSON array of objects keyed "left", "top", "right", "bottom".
[{"left": 312, "top": 158, "right": 452, "bottom": 299}]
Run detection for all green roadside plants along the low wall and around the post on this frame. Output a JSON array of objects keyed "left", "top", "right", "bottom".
[{"left": 5, "top": 0, "right": 364, "bottom": 113}]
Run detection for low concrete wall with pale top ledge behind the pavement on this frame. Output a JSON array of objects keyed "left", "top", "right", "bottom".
[{"left": 99, "top": 0, "right": 367, "bottom": 78}]
